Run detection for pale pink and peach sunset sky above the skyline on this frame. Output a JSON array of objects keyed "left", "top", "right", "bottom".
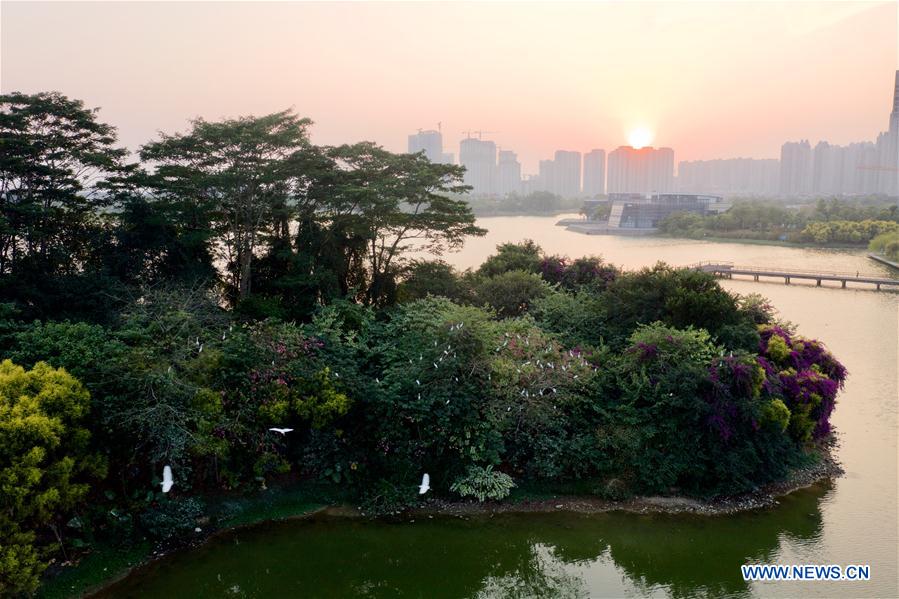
[{"left": 0, "top": 1, "right": 899, "bottom": 173}]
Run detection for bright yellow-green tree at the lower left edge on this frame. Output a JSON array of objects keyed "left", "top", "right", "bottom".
[{"left": 0, "top": 360, "right": 105, "bottom": 595}]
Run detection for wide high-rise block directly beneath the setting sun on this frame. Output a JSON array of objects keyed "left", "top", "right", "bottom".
[{"left": 606, "top": 146, "right": 674, "bottom": 193}]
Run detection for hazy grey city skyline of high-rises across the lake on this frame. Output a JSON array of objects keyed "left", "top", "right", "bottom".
[{"left": 407, "top": 69, "right": 899, "bottom": 198}]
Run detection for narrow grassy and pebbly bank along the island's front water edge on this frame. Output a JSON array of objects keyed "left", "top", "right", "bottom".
[{"left": 44, "top": 447, "right": 843, "bottom": 599}]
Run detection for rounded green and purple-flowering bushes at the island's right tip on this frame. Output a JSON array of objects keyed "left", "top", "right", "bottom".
[{"left": 598, "top": 322, "right": 846, "bottom": 495}]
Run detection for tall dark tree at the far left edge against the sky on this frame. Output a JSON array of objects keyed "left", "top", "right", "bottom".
[{"left": 0, "top": 92, "right": 125, "bottom": 315}]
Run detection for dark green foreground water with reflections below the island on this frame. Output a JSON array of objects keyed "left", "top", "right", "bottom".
[{"left": 101, "top": 487, "right": 830, "bottom": 597}]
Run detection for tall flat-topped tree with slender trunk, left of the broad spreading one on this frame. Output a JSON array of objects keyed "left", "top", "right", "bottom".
[{"left": 141, "top": 110, "right": 312, "bottom": 301}]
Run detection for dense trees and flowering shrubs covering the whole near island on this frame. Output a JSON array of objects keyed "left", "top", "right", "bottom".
[{"left": 0, "top": 93, "right": 847, "bottom": 595}]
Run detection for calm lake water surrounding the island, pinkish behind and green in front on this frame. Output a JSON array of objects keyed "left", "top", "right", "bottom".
[{"left": 98, "top": 217, "right": 899, "bottom": 598}]
